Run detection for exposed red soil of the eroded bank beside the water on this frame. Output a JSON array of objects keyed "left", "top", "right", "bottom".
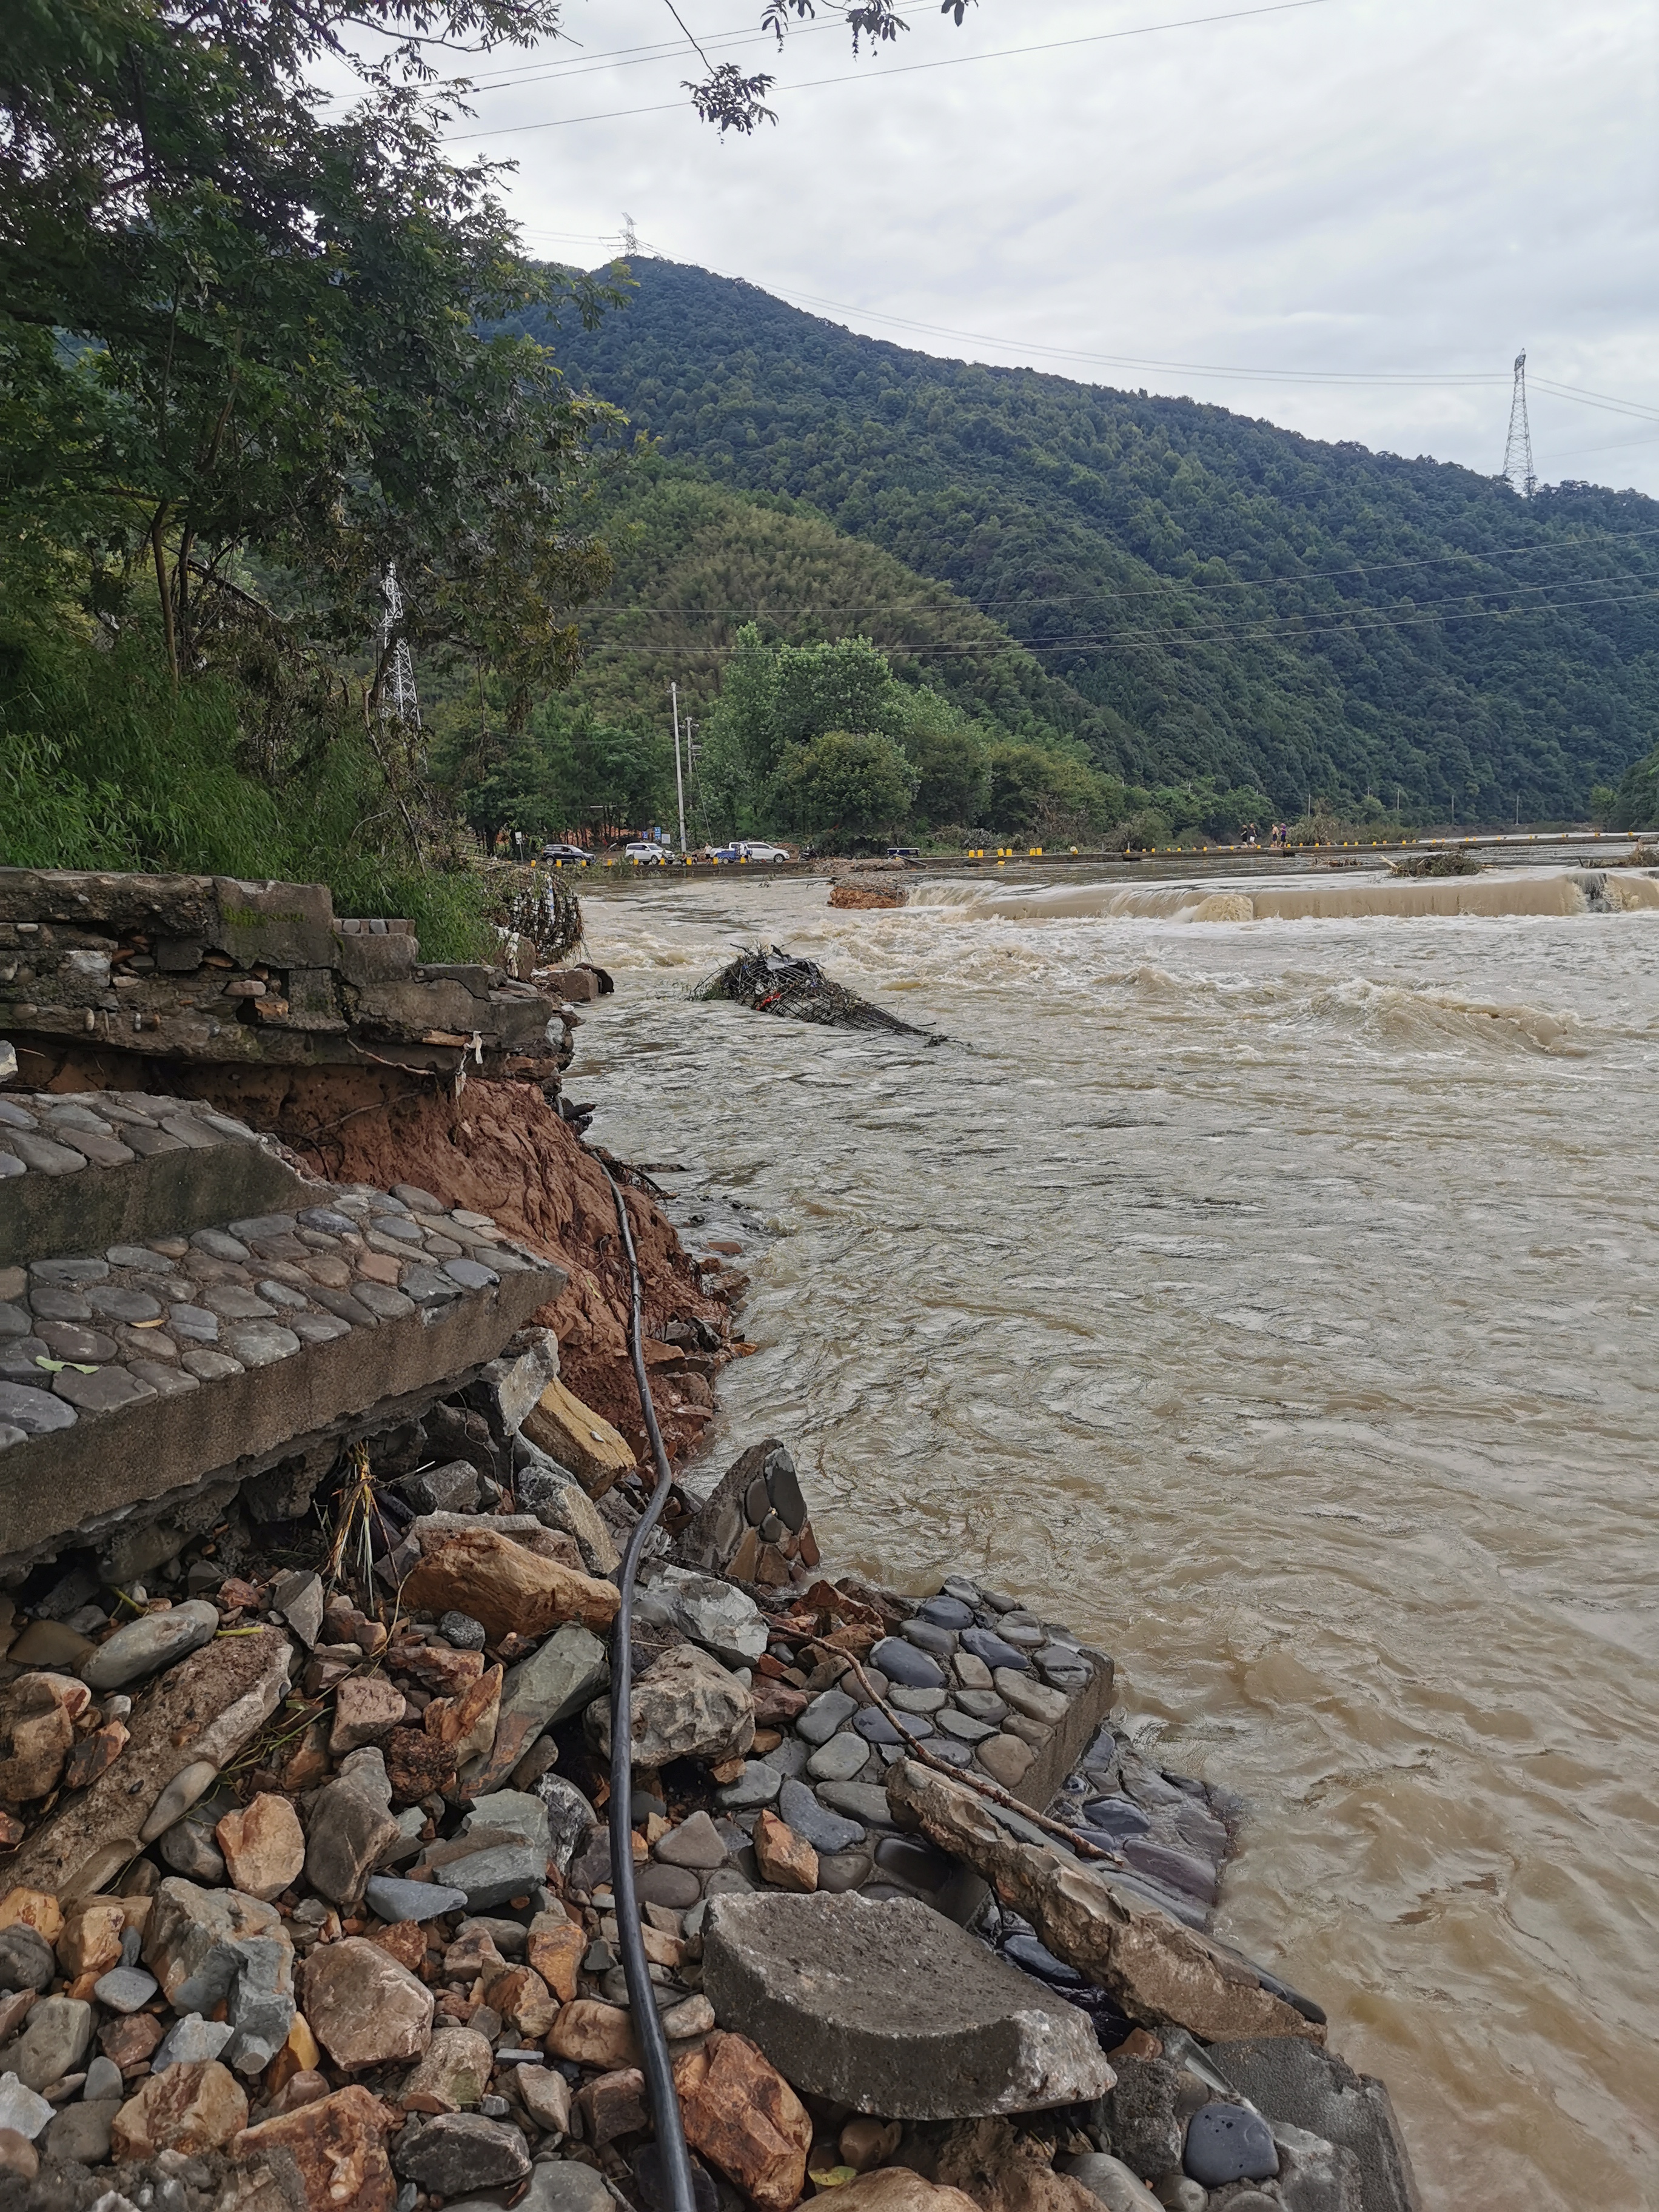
[{"left": 298, "top": 1079, "right": 730, "bottom": 1460}]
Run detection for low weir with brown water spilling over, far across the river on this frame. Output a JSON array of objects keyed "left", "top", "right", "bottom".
[{"left": 907, "top": 867, "right": 1659, "bottom": 922}]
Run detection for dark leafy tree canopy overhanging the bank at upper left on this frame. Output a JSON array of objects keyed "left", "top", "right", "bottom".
[{"left": 0, "top": 0, "right": 617, "bottom": 716}]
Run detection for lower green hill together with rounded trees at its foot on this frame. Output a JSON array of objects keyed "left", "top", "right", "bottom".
[{"left": 424, "top": 455, "right": 1270, "bottom": 843}]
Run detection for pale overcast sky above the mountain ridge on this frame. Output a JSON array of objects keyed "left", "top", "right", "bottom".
[{"left": 438, "top": 0, "right": 1659, "bottom": 494}]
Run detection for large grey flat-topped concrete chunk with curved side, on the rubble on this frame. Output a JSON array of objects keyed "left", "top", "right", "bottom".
[{"left": 703, "top": 1891, "right": 1113, "bottom": 2119}]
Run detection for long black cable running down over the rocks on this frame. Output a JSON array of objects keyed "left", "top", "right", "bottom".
[{"left": 600, "top": 1161, "right": 697, "bottom": 2212}]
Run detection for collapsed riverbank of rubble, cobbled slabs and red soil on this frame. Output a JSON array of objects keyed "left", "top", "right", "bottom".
[{"left": 0, "top": 878, "right": 1416, "bottom": 2212}]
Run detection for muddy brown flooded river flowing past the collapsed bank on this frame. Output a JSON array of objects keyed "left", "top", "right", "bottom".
[{"left": 571, "top": 870, "right": 1659, "bottom": 2212}]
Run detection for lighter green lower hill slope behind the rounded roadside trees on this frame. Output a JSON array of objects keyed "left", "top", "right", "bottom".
[{"left": 423, "top": 455, "right": 1185, "bottom": 839}]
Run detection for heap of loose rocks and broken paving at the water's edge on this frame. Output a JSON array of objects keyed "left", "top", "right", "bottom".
[{"left": 0, "top": 1362, "right": 1411, "bottom": 2212}]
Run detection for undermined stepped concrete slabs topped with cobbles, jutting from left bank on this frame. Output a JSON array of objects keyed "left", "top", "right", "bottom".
[{"left": 0, "top": 1090, "right": 566, "bottom": 1580}]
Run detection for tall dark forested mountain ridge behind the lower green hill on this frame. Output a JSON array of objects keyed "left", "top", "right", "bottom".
[{"left": 528, "top": 261, "right": 1659, "bottom": 820}]
